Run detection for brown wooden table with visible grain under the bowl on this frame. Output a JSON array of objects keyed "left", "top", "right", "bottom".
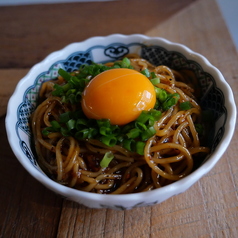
[{"left": 0, "top": 0, "right": 238, "bottom": 238}]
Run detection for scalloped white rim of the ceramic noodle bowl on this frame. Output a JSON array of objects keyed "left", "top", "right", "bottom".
[{"left": 5, "top": 34, "right": 237, "bottom": 204}]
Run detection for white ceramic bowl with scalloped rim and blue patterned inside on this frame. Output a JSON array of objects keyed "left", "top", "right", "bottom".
[{"left": 6, "top": 34, "right": 236, "bottom": 210}]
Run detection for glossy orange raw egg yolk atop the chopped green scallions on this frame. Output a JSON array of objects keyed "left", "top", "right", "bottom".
[{"left": 82, "top": 68, "right": 156, "bottom": 125}]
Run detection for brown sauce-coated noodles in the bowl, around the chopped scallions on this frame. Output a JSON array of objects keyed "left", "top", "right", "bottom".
[{"left": 31, "top": 55, "right": 209, "bottom": 194}]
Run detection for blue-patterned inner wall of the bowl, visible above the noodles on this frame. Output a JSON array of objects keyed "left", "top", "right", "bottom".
[{"left": 16, "top": 42, "right": 227, "bottom": 175}]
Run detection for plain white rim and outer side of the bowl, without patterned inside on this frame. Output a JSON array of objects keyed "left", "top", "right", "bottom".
[{"left": 6, "top": 34, "right": 236, "bottom": 209}]
